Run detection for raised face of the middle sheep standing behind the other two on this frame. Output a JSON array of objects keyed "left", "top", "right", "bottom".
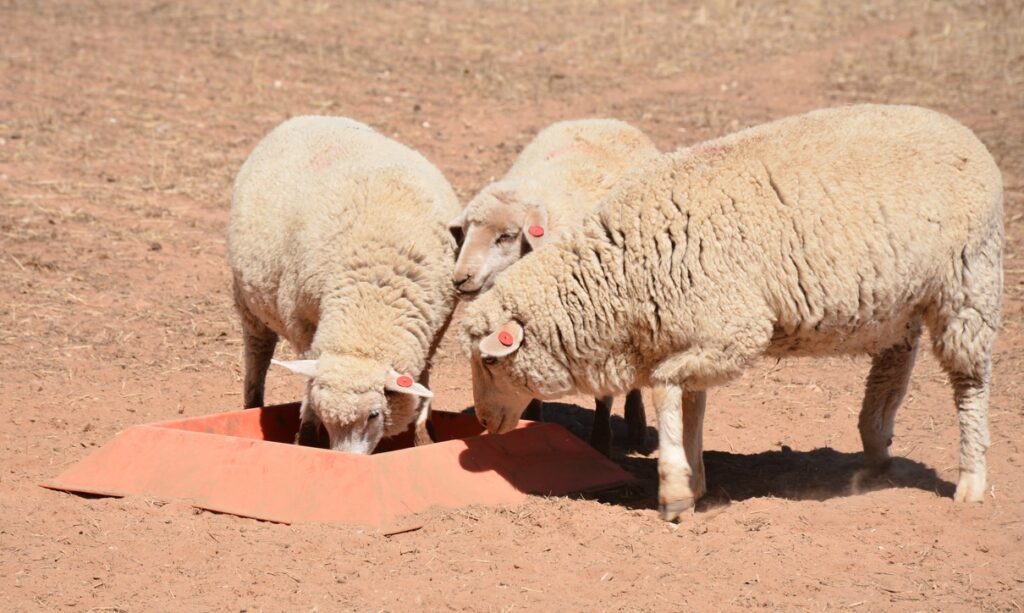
[{"left": 450, "top": 189, "right": 548, "bottom": 300}]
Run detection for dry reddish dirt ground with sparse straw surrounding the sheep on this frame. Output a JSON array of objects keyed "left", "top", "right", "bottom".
[{"left": 0, "top": 0, "right": 1024, "bottom": 611}]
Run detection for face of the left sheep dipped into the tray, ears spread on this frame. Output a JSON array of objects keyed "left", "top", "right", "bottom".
[{"left": 274, "top": 356, "right": 432, "bottom": 453}]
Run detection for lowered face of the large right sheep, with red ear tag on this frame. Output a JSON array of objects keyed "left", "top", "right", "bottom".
[{"left": 472, "top": 321, "right": 573, "bottom": 434}]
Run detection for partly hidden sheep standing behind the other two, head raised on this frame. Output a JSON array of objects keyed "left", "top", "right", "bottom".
[{"left": 450, "top": 119, "right": 659, "bottom": 455}]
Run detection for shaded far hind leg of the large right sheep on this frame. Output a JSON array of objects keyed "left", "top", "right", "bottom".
[{"left": 857, "top": 321, "right": 921, "bottom": 472}]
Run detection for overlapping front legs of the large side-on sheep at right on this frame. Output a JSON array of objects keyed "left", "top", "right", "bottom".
[{"left": 654, "top": 385, "right": 708, "bottom": 521}]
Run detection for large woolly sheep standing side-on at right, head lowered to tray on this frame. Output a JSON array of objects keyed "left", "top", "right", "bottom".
[{"left": 460, "top": 104, "right": 1004, "bottom": 521}]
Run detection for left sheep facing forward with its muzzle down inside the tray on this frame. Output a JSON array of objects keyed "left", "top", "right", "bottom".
[{"left": 227, "top": 117, "right": 460, "bottom": 453}]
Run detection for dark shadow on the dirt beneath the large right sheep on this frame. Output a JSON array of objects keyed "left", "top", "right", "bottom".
[{"left": 466, "top": 403, "right": 955, "bottom": 513}]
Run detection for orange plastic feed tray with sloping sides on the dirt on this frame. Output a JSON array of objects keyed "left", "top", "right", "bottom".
[{"left": 43, "top": 403, "right": 632, "bottom": 526}]
